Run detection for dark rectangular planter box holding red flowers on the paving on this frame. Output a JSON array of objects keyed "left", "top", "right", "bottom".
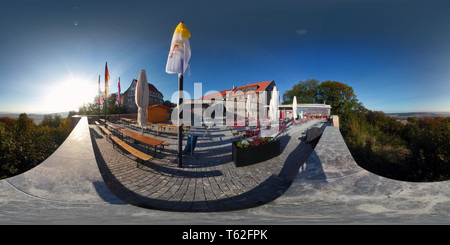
[{"left": 232, "top": 140, "right": 280, "bottom": 167}]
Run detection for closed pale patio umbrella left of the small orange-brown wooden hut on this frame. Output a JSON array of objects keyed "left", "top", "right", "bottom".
[{"left": 134, "top": 70, "right": 149, "bottom": 134}]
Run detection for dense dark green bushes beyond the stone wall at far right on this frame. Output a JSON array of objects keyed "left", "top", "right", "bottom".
[{"left": 340, "top": 106, "right": 450, "bottom": 182}]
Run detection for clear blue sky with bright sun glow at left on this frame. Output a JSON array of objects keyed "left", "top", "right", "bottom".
[{"left": 0, "top": 0, "right": 450, "bottom": 113}]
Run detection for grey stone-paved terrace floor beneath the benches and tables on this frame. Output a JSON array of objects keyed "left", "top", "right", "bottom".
[{"left": 90, "top": 120, "right": 329, "bottom": 212}]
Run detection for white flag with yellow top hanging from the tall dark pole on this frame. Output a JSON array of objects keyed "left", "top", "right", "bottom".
[{"left": 166, "top": 22, "right": 191, "bottom": 75}]
